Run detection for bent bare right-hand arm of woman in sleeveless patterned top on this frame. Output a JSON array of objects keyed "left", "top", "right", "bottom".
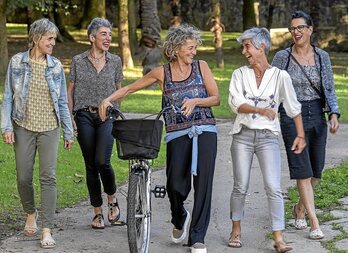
[{"left": 180, "top": 61, "right": 220, "bottom": 116}]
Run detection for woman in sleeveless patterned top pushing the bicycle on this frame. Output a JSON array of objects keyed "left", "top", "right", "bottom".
[{"left": 99, "top": 24, "right": 220, "bottom": 253}]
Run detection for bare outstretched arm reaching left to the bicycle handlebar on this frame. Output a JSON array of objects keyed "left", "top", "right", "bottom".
[{"left": 98, "top": 66, "right": 164, "bottom": 121}]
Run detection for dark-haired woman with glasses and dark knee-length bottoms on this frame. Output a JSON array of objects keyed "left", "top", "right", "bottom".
[{"left": 272, "top": 11, "right": 340, "bottom": 239}]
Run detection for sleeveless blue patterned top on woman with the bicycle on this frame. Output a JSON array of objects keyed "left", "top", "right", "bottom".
[{"left": 162, "top": 60, "right": 216, "bottom": 132}]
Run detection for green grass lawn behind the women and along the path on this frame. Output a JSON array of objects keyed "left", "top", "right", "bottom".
[{"left": 0, "top": 24, "right": 348, "bottom": 237}]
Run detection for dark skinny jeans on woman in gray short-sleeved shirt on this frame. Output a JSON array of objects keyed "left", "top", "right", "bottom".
[{"left": 75, "top": 111, "right": 116, "bottom": 207}]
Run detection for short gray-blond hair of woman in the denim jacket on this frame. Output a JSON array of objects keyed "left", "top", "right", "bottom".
[{"left": 28, "top": 18, "right": 59, "bottom": 49}]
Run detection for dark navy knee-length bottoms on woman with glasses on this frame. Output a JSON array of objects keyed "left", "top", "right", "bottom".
[{"left": 279, "top": 99, "right": 327, "bottom": 179}]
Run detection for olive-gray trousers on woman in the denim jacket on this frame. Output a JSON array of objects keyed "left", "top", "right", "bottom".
[{"left": 14, "top": 124, "right": 60, "bottom": 228}]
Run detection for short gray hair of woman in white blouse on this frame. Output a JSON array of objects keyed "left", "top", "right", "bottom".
[{"left": 237, "top": 27, "right": 272, "bottom": 55}]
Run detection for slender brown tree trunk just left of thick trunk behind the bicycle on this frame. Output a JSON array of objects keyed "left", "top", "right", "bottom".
[{"left": 128, "top": 0, "right": 139, "bottom": 57}]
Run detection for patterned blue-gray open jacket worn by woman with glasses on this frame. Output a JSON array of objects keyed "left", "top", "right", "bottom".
[{"left": 272, "top": 45, "right": 340, "bottom": 118}]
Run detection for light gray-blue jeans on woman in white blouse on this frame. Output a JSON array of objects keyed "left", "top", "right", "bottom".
[{"left": 230, "top": 126, "right": 285, "bottom": 231}]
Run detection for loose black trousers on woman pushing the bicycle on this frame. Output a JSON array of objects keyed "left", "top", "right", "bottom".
[{"left": 166, "top": 132, "right": 217, "bottom": 246}]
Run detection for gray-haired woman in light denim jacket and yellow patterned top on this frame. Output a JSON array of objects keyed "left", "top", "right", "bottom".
[{"left": 1, "top": 18, "right": 74, "bottom": 248}]
